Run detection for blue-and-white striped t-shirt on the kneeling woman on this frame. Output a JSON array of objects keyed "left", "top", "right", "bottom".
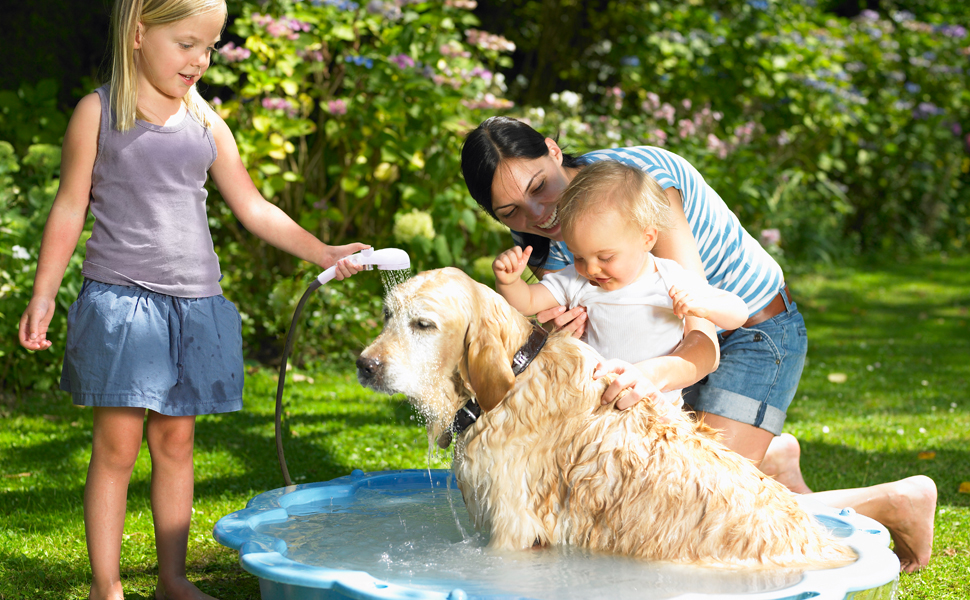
[{"left": 512, "top": 146, "right": 785, "bottom": 315}]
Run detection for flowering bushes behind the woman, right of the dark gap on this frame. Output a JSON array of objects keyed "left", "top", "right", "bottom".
[{"left": 485, "top": 0, "right": 970, "bottom": 261}]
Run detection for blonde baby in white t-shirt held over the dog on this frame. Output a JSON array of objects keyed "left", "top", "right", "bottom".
[{"left": 492, "top": 161, "right": 748, "bottom": 405}]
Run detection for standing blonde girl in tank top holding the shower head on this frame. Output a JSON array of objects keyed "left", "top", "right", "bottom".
[{"left": 19, "top": 0, "right": 367, "bottom": 599}]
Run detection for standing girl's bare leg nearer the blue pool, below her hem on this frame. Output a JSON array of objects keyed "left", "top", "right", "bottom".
[{"left": 148, "top": 411, "right": 214, "bottom": 600}]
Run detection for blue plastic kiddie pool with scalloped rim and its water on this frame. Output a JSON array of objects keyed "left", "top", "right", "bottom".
[{"left": 213, "top": 470, "right": 899, "bottom": 600}]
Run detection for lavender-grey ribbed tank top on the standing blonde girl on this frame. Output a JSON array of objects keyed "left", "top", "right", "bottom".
[{"left": 81, "top": 86, "right": 222, "bottom": 298}]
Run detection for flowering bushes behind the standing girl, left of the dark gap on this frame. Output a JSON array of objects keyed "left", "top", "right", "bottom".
[{"left": 0, "top": 0, "right": 509, "bottom": 386}]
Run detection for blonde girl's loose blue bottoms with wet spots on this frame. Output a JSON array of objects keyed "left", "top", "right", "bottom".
[{"left": 61, "top": 279, "right": 243, "bottom": 416}]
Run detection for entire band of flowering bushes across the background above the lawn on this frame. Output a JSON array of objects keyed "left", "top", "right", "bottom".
[{"left": 0, "top": 0, "right": 970, "bottom": 387}]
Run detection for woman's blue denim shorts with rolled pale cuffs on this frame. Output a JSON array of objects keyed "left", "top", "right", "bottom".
[{"left": 684, "top": 294, "right": 808, "bottom": 435}]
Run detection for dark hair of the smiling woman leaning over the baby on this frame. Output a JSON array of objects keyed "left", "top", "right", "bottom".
[{"left": 461, "top": 117, "right": 582, "bottom": 275}]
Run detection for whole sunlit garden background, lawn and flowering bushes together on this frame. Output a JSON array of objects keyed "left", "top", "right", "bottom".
[{"left": 0, "top": 0, "right": 970, "bottom": 600}]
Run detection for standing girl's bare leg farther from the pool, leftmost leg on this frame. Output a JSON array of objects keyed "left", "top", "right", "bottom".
[{"left": 84, "top": 407, "right": 145, "bottom": 600}]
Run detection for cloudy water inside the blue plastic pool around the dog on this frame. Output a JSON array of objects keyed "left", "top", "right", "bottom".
[{"left": 257, "top": 487, "right": 802, "bottom": 600}]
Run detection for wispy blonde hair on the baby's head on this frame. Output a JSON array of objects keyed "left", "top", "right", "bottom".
[{"left": 559, "top": 160, "right": 671, "bottom": 238}]
